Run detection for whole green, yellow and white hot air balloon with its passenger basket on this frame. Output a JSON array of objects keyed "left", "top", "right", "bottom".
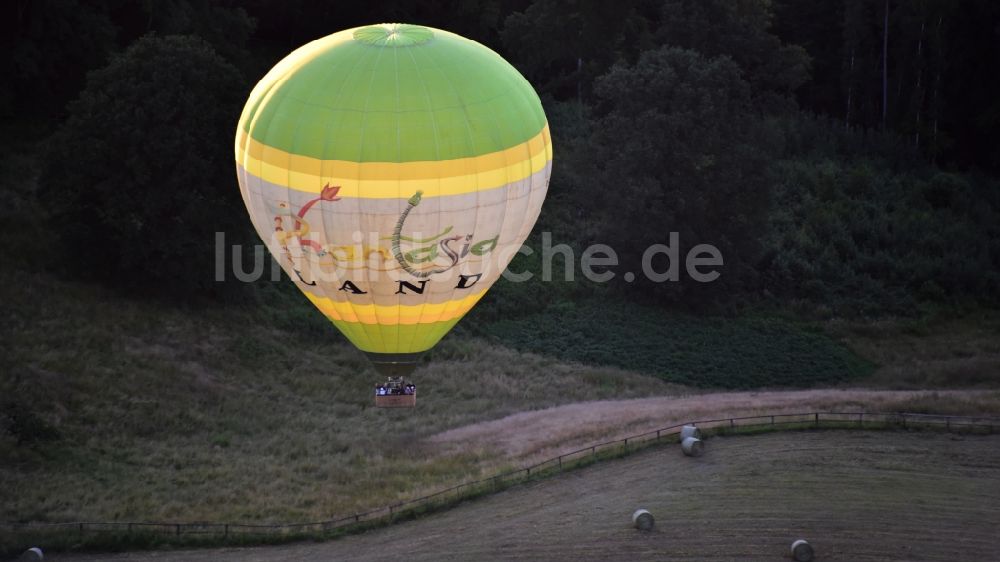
[{"left": 235, "top": 24, "right": 552, "bottom": 405}]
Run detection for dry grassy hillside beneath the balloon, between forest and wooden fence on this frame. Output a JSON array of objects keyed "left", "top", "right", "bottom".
[{"left": 0, "top": 258, "right": 1000, "bottom": 522}]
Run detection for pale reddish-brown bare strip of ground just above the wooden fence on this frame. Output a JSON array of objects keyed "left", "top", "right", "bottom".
[{"left": 430, "top": 389, "right": 997, "bottom": 461}]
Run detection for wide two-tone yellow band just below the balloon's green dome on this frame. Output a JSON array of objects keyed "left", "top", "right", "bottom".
[{"left": 236, "top": 125, "right": 552, "bottom": 199}]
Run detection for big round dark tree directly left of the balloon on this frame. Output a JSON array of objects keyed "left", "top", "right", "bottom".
[{"left": 39, "top": 36, "right": 248, "bottom": 293}]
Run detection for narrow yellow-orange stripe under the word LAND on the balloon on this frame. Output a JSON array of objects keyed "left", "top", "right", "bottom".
[{"left": 305, "top": 290, "right": 486, "bottom": 325}]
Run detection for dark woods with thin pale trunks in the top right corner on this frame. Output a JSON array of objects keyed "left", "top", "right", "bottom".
[{"left": 776, "top": 0, "right": 1000, "bottom": 171}]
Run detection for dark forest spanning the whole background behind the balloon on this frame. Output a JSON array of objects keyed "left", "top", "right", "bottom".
[{"left": 0, "top": 0, "right": 1000, "bottom": 315}]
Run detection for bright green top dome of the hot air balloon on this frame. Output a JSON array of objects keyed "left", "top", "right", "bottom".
[{"left": 240, "top": 24, "right": 545, "bottom": 162}]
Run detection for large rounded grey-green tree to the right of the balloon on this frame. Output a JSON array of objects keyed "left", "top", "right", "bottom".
[{"left": 576, "top": 47, "right": 773, "bottom": 302}]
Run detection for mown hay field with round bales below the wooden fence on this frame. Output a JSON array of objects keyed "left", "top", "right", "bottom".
[{"left": 47, "top": 431, "right": 1000, "bottom": 562}]
